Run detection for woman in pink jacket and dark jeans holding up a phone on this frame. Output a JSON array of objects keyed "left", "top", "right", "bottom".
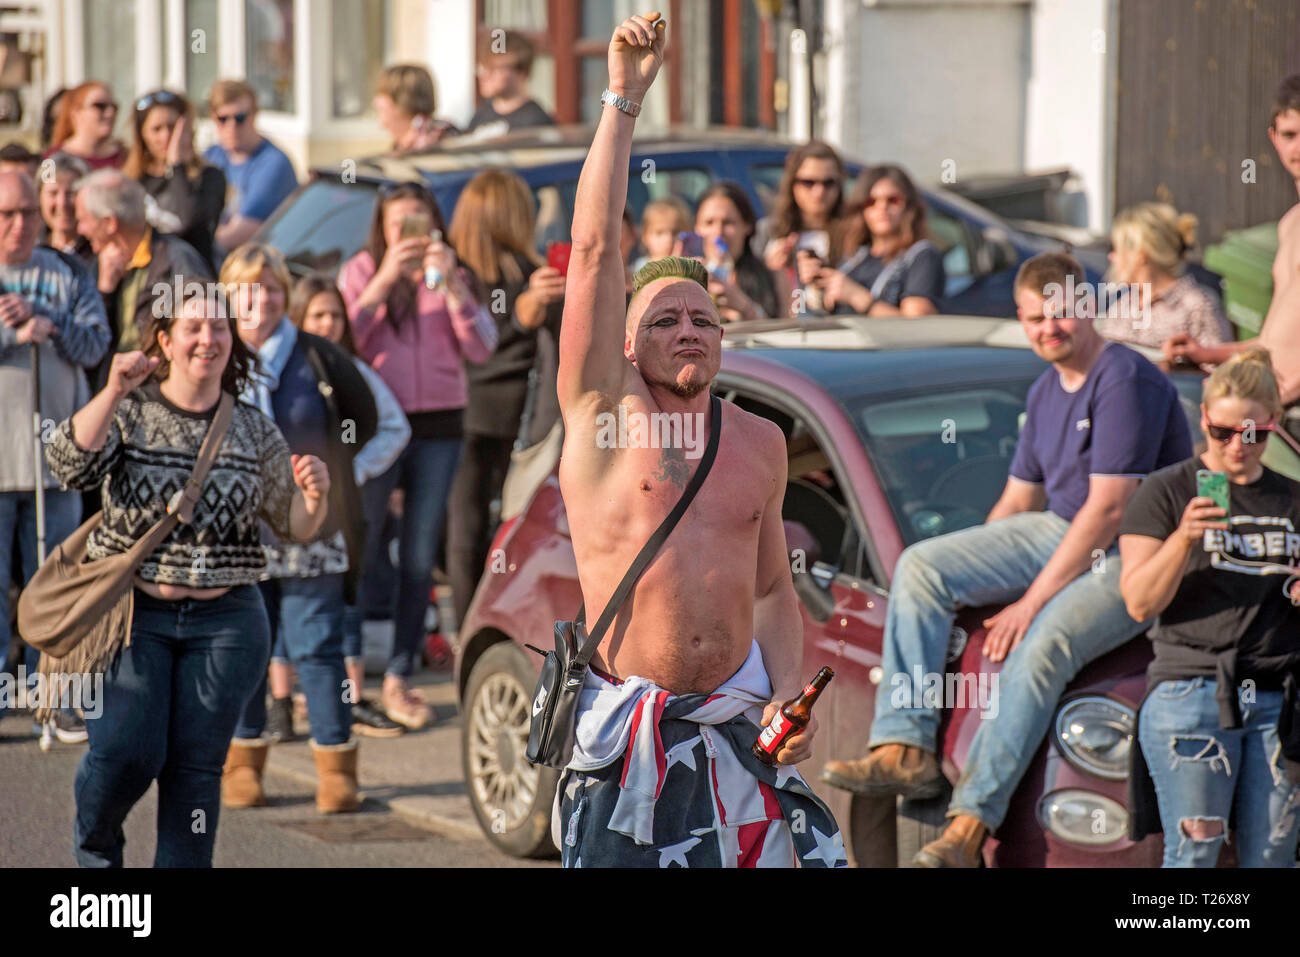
[{"left": 338, "top": 182, "right": 497, "bottom": 728}]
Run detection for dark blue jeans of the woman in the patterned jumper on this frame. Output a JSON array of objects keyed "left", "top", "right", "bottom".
[{"left": 74, "top": 585, "right": 270, "bottom": 867}]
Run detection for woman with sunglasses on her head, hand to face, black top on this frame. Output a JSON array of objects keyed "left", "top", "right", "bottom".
[{"left": 122, "top": 90, "right": 226, "bottom": 269}]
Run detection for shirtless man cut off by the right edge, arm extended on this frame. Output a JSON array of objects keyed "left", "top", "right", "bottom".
[{"left": 1164, "top": 73, "right": 1300, "bottom": 416}]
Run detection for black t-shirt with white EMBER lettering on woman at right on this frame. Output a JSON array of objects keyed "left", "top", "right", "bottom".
[{"left": 1119, "top": 458, "right": 1300, "bottom": 689}]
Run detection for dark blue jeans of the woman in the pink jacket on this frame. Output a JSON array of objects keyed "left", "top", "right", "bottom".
[{"left": 358, "top": 438, "right": 462, "bottom": 679}]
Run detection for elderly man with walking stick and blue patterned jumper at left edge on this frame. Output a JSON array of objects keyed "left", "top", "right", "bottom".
[{"left": 0, "top": 170, "right": 109, "bottom": 741}]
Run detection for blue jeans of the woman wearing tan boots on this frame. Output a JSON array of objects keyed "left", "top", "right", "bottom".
[{"left": 235, "top": 575, "right": 352, "bottom": 745}]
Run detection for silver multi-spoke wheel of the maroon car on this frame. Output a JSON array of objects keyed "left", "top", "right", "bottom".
[{"left": 462, "top": 641, "right": 559, "bottom": 857}]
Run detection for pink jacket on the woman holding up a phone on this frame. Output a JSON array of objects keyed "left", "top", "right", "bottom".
[{"left": 338, "top": 250, "right": 497, "bottom": 412}]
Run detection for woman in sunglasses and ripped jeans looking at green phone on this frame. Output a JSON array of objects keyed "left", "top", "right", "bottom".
[{"left": 1119, "top": 348, "right": 1300, "bottom": 867}]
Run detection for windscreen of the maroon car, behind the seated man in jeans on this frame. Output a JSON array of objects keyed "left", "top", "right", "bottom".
[{"left": 846, "top": 376, "right": 1034, "bottom": 545}]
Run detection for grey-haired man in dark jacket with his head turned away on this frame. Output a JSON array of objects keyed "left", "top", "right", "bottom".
[{"left": 75, "top": 169, "right": 213, "bottom": 390}]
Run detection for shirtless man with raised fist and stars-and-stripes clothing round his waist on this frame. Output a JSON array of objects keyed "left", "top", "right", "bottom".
[{"left": 556, "top": 13, "right": 844, "bottom": 866}]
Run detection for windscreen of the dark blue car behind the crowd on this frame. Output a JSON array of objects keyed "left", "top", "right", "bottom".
[{"left": 260, "top": 179, "right": 378, "bottom": 276}]
